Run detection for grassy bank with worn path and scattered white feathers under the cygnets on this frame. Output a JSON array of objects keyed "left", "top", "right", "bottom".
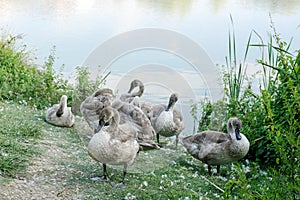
[{"left": 0, "top": 102, "right": 270, "bottom": 199}]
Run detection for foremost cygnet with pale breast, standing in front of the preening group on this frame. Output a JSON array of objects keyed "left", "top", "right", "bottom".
[{"left": 88, "top": 106, "right": 139, "bottom": 188}]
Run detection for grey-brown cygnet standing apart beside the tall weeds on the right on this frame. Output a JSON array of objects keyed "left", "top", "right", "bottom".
[{"left": 180, "top": 118, "right": 250, "bottom": 175}]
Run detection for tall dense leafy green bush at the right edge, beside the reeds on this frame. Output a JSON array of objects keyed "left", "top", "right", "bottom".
[{"left": 255, "top": 30, "right": 300, "bottom": 198}]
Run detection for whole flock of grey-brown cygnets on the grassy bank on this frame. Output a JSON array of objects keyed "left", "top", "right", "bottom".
[{"left": 46, "top": 80, "right": 250, "bottom": 187}]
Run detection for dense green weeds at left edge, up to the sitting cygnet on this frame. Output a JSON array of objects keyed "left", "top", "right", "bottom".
[{"left": 0, "top": 35, "right": 69, "bottom": 108}]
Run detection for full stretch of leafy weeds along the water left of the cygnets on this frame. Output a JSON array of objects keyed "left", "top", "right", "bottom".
[{"left": 0, "top": 34, "right": 109, "bottom": 114}]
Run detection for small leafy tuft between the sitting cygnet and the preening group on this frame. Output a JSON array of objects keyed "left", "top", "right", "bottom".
[{"left": 72, "top": 66, "right": 110, "bottom": 115}]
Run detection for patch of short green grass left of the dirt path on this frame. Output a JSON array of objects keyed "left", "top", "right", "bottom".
[{"left": 0, "top": 102, "right": 41, "bottom": 177}]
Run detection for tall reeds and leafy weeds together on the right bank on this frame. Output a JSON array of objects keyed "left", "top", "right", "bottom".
[{"left": 192, "top": 22, "right": 300, "bottom": 199}]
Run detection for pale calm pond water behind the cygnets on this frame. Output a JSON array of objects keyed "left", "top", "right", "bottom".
[{"left": 0, "top": 0, "right": 300, "bottom": 134}]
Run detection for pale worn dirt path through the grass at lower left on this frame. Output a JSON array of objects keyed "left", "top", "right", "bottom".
[{"left": 0, "top": 118, "right": 89, "bottom": 200}]
